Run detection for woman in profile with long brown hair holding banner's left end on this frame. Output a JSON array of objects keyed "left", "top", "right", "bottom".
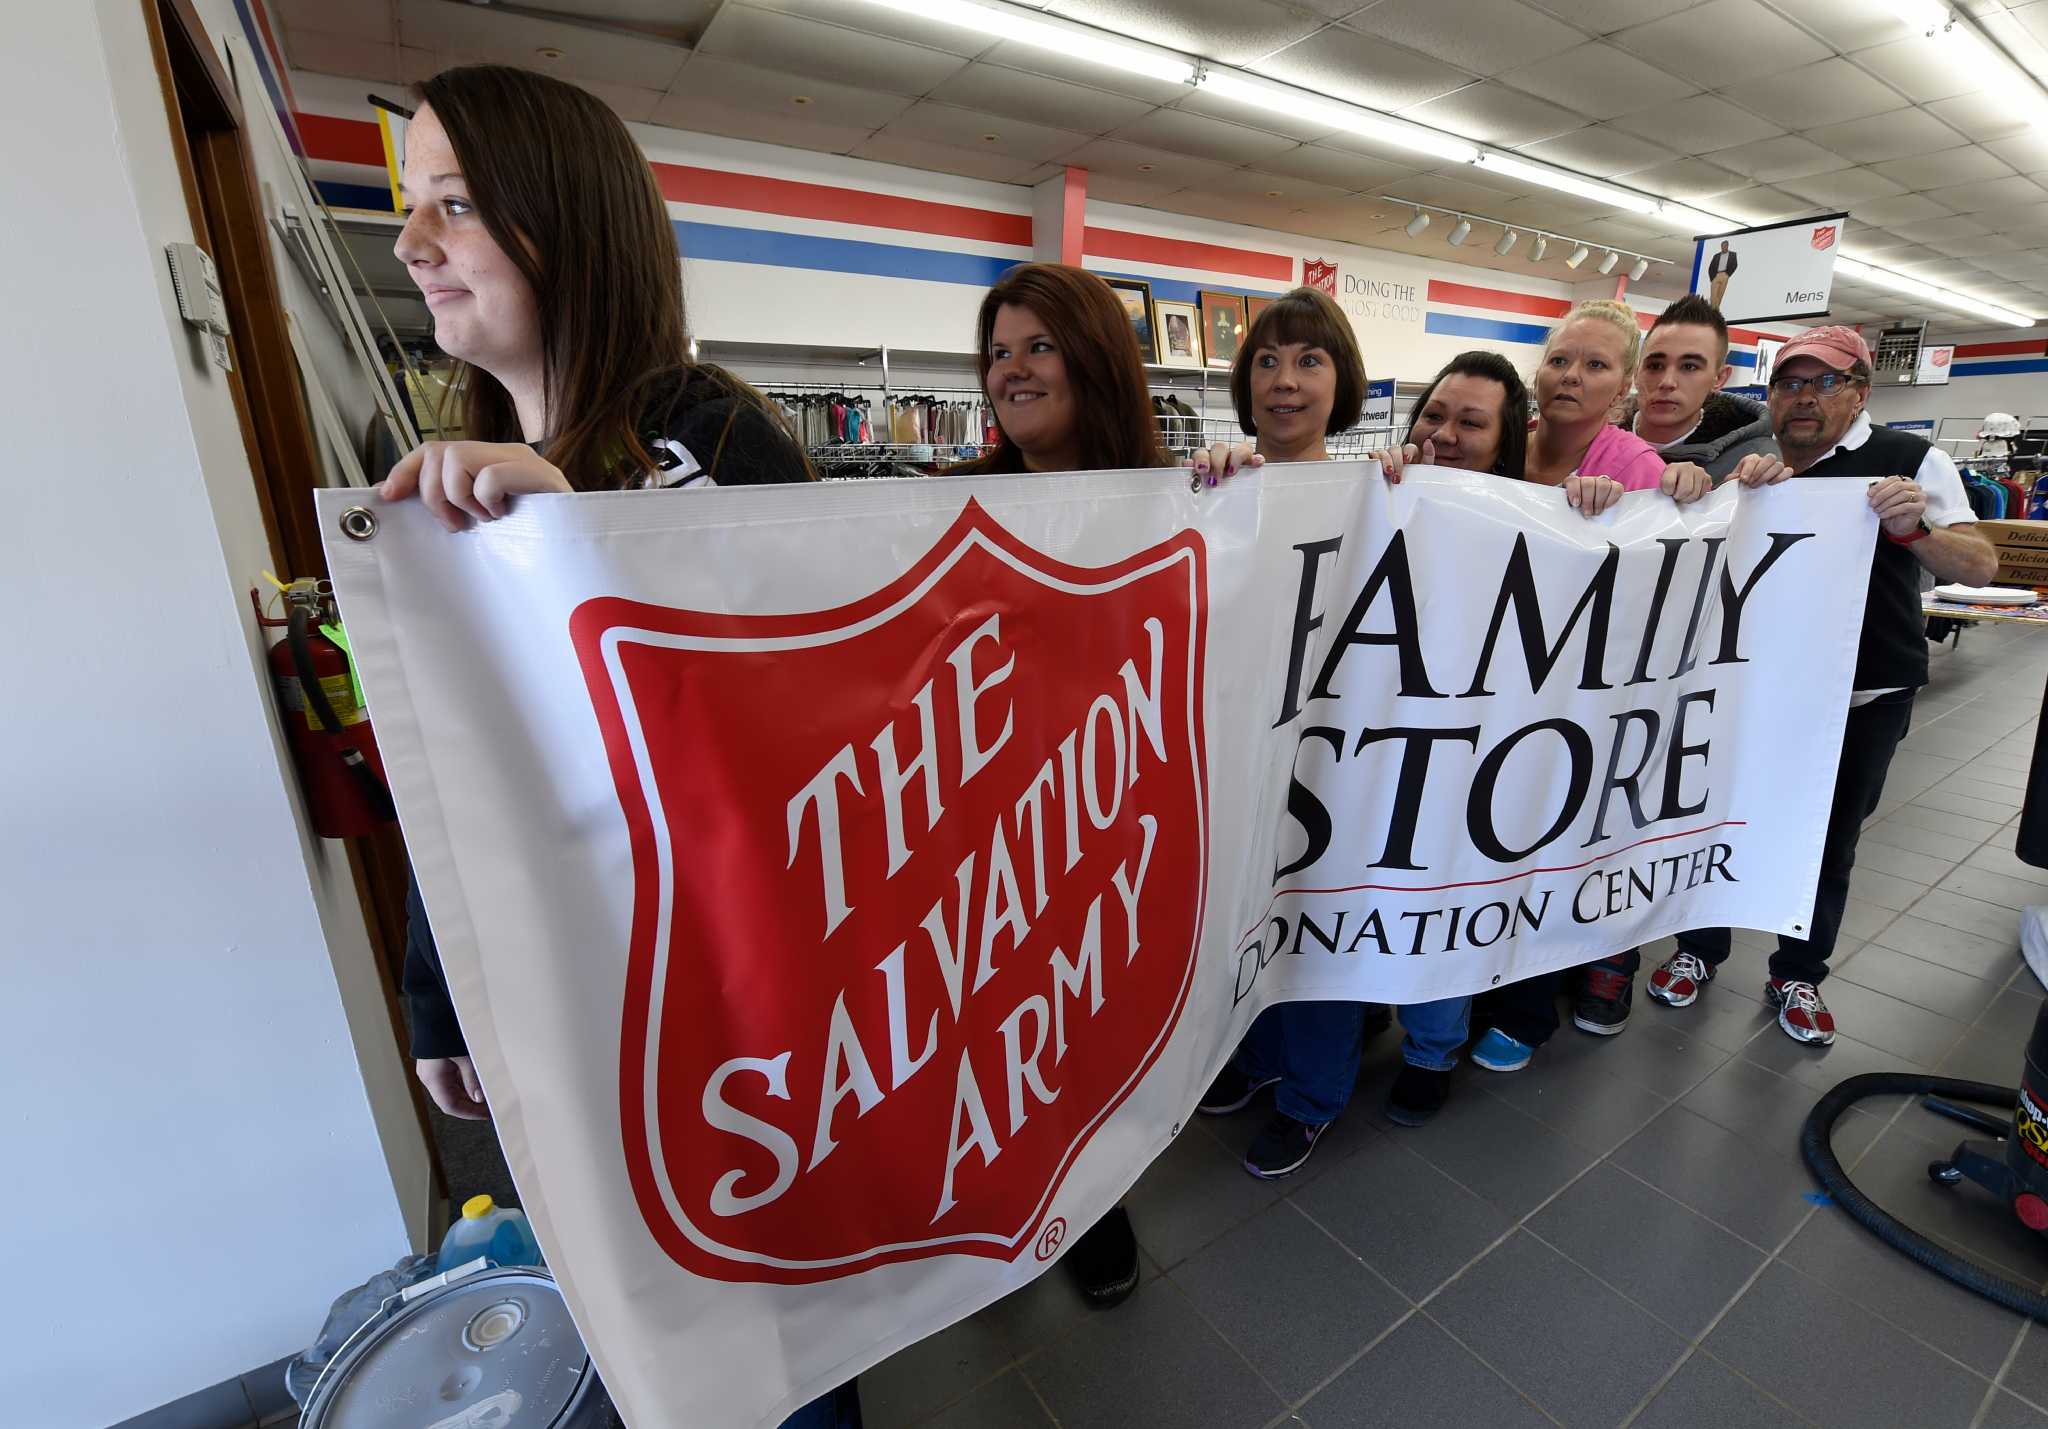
[{"left": 381, "top": 66, "right": 860, "bottom": 1429}]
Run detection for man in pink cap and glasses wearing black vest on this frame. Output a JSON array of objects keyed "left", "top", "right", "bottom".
[{"left": 1649, "top": 328, "right": 1999, "bottom": 1046}]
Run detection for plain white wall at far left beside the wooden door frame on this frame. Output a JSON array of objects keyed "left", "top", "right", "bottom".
[{"left": 0, "top": 0, "right": 408, "bottom": 1429}]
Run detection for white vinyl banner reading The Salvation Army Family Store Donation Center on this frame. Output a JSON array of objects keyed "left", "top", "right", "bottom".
[{"left": 319, "top": 463, "right": 1876, "bottom": 1429}]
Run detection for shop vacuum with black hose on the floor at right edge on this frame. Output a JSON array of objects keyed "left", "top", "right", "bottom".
[{"left": 1798, "top": 683, "right": 2048, "bottom": 1325}]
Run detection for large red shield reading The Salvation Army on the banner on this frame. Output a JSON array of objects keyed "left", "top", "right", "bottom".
[{"left": 571, "top": 502, "right": 1208, "bottom": 1284}]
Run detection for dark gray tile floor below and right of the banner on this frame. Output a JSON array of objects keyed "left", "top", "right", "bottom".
[{"left": 862, "top": 629, "right": 2048, "bottom": 1429}]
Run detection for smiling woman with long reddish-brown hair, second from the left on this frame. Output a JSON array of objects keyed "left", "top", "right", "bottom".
[{"left": 948, "top": 262, "right": 1264, "bottom": 1308}]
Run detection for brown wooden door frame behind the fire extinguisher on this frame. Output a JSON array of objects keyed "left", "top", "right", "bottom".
[{"left": 141, "top": 0, "right": 446, "bottom": 1196}]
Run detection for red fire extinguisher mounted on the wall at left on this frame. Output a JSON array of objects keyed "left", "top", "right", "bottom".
[{"left": 250, "top": 579, "right": 397, "bottom": 839}]
